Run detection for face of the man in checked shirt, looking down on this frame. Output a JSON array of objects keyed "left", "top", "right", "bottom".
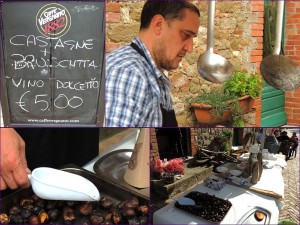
[{"left": 153, "top": 9, "right": 200, "bottom": 70}]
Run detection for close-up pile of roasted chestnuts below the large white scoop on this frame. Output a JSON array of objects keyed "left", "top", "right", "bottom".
[{"left": 0, "top": 195, "right": 149, "bottom": 224}]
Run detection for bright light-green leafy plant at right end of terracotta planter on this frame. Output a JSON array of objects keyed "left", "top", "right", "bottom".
[{"left": 224, "top": 71, "right": 263, "bottom": 99}]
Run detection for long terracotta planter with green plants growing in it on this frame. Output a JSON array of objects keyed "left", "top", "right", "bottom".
[{"left": 188, "top": 71, "right": 263, "bottom": 126}]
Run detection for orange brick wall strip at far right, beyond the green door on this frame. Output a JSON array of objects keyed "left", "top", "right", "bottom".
[{"left": 284, "top": 1, "right": 300, "bottom": 126}]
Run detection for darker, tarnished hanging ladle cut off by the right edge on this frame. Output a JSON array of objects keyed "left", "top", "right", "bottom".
[{"left": 260, "top": 1, "right": 300, "bottom": 91}]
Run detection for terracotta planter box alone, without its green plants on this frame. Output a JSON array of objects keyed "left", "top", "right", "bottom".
[{"left": 191, "top": 95, "right": 254, "bottom": 125}]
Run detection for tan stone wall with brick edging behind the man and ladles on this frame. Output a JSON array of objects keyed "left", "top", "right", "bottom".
[{"left": 106, "top": 0, "right": 263, "bottom": 126}]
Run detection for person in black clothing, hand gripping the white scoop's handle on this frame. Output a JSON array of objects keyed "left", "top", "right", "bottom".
[{"left": 0, "top": 128, "right": 99, "bottom": 192}]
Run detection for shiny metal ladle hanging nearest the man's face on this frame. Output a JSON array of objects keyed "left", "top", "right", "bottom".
[{"left": 197, "top": 0, "right": 233, "bottom": 83}]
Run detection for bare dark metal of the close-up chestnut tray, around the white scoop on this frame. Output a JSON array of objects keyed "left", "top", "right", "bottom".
[{"left": 0, "top": 165, "right": 152, "bottom": 224}]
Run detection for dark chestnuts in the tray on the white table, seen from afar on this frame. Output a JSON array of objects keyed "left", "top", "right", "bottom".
[{"left": 175, "top": 191, "right": 232, "bottom": 223}]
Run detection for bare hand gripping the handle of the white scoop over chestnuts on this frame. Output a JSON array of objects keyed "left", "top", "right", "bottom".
[{"left": 0, "top": 128, "right": 30, "bottom": 190}]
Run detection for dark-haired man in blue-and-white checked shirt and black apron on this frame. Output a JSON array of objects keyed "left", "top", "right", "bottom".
[{"left": 105, "top": 0, "right": 200, "bottom": 127}]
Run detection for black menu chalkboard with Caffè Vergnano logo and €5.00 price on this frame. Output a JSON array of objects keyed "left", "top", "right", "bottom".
[{"left": 1, "top": 1, "right": 105, "bottom": 126}]
